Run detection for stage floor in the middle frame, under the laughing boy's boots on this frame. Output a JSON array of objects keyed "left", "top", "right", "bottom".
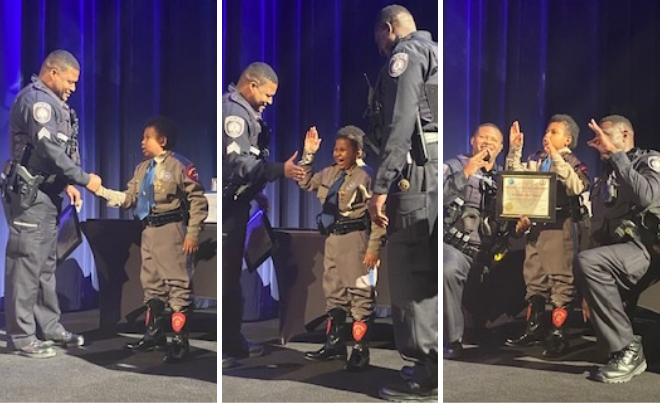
[{"left": 222, "top": 318, "right": 428, "bottom": 403}]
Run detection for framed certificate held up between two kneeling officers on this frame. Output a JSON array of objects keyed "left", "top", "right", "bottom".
[{"left": 497, "top": 171, "right": 557, "bottom": 223}]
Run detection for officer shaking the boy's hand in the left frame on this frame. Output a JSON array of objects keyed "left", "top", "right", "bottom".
[{"left": 3, "top": 50, "right": 101, "bottom": 358}]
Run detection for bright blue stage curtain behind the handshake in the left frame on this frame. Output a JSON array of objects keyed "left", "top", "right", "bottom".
[{"left": 0, "top": 0, "right": 217, "bottom": 310}]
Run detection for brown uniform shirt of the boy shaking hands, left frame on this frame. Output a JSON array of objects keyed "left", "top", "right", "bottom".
[{"left": 99, "top": 150, "right": 209, "bottom": 240}]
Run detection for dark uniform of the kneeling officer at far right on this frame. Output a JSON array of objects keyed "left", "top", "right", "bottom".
[{"left": 576, "top": 149, "right": 660, "bottom": 382}]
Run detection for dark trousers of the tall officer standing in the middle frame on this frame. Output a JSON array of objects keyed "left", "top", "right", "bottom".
[{"left": 387, "top": 143, "right": 438, "bottom": 388}]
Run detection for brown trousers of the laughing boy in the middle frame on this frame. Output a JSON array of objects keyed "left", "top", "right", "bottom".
[{"left": 323, "top": 230, "right": 375, "bottom": 321}]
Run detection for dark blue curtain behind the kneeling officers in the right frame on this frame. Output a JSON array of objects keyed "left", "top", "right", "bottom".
[{"left": 443, "top": 0, "right": 660, "bottom": 178}]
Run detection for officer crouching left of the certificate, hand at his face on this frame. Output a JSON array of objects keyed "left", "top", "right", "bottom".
[{"left": 442, "top": 123, "right": 502, "bottom": 359}]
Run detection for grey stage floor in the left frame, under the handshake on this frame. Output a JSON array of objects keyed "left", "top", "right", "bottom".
[{"left": 0, "top": 310, "right": 218, "bottom": 402}]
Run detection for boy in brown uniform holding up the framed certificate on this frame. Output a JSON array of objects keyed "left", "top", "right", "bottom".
[{"left": 506, "top": 114, "right": 589, "bottom": 357}]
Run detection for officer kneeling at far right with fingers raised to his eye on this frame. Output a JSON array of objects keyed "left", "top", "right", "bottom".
[{"left": 577, "top": 115, "right": 660, "bottom": 383}]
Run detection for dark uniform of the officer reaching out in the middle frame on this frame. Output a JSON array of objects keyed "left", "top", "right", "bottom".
[{"left": 222, "top": 86, "right": 284, "bottom": 357}]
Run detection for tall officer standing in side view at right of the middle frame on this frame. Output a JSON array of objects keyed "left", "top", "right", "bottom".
[{"left": 369, "top": 5, "right": 438, "bottom": 401}]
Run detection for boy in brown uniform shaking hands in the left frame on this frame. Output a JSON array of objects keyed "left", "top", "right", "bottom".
[{"left": 97, "top": 117, "right": 208, "bottom": 362}]
